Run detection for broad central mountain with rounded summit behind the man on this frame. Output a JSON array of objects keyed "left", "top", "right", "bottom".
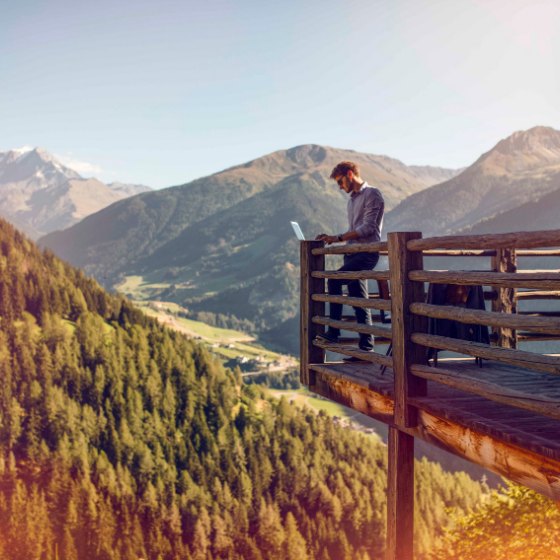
[{"left": 40, "top": 145, "right": 457, "bottom": 336}]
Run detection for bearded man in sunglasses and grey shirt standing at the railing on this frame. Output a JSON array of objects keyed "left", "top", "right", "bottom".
[{"left": 315, "top": 161, "right": 385, "bottom": 362}]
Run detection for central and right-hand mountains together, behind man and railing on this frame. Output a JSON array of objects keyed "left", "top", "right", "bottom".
[{"left": 34, "top": 127, "right": 560, "bottom": 352}]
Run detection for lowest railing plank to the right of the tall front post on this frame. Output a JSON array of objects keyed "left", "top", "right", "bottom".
[{"left": 410, "top": 364, "right": 560, "bottom": 420}]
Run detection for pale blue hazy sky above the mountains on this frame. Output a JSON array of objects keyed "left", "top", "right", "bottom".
[{"left": 0, "top": 0, "right": 560, "bottom": 188}]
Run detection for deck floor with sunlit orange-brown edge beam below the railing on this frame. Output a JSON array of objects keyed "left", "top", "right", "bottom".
[{"left": 310, "top": 363, "right": 560, "bottom": 501}]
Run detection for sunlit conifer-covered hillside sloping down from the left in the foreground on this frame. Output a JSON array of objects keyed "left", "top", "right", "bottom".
[{"left": 0, "top": 215, "right": 486, "bottom": 560}]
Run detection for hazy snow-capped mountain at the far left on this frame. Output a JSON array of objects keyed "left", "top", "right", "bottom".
[{"left": 0, "top": 148, "right": 149, "bottom": 239}]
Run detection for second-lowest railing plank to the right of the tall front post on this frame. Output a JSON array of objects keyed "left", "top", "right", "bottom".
[{"left": 410, "top": 333, "right": 560, "bottom": 375}]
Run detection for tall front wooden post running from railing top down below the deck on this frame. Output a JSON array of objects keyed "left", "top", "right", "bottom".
[{"left": 385, "top": 232, "right": 427, "bottom": 560}]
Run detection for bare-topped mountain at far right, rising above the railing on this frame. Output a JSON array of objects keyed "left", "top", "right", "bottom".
[{"left": 384, "top": 126, "right": 560, "bottom": 236}]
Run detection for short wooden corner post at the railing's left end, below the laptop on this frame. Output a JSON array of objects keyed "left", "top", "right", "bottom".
[{"left": 299, "top": 241, "right": 325, "bottom": 386}]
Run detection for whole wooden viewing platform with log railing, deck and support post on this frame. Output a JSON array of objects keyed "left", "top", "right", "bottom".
[{"left": 300, "top": 230, "right": 560, "bottom": 560}]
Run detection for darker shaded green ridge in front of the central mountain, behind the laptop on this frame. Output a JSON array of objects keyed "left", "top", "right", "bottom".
[{"left": 132, "top": 174, "right": 345, "bottom": 326}]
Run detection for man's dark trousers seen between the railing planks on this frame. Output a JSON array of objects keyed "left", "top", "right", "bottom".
[{"left": 328, "top": 253, "right": 379, "bottom": 350}]
